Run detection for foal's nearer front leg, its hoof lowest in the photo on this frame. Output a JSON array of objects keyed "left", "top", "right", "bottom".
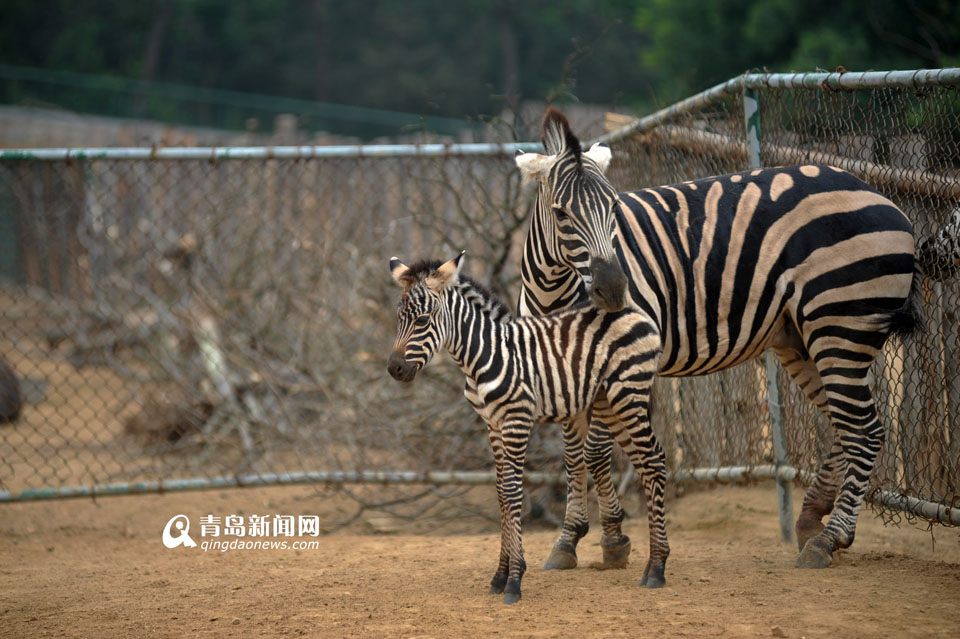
[{"left": 501, "top": 422, "right": 531, "bottom": 604}]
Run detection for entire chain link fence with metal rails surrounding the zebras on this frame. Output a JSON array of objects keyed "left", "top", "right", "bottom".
[{"left": 0, "top": 66, "right": 960, "bottom": 536}]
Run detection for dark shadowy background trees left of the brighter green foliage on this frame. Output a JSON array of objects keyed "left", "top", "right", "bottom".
[{"left": 0, "top": 0, "right": 644, "bottom": 124}]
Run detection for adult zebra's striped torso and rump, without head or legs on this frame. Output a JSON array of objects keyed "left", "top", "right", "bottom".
[{"left": 615, "top": 166, "right": 914, "bottom": 376}]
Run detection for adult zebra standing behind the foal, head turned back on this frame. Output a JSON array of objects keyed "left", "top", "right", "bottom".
[{"left": 516, "top": 109, "right": 935, "bottom": 569}]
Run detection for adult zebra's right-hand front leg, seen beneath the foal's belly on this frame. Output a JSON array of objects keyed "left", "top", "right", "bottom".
[{"left": 584, "top": 391, "right": 630, "bottom": 570}]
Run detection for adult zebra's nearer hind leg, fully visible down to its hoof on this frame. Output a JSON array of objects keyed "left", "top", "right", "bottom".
[{"left": 796, "top": 344, "right": 884, "bottom": 568}]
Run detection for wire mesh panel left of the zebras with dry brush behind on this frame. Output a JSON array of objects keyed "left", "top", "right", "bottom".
[{"left": 0, "top": 155, "right": 559, "bottom": 528}]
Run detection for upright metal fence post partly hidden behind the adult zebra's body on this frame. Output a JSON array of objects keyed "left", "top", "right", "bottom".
[{"left": 743, "top": 87, "right": 793, "bottom": 542}]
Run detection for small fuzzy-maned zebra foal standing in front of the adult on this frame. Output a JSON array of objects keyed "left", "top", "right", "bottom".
[{"left": 387, "top": 253, "right": 670, "bottom": 604}]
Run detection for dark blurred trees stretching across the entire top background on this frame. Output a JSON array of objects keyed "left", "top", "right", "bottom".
[{"left": 0, "top": 0, "right": 960, "bottom": 129}]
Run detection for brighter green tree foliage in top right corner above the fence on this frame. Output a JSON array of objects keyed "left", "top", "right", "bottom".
[{"left": 634, "top": 0, "right": 960, "bottom": 103}]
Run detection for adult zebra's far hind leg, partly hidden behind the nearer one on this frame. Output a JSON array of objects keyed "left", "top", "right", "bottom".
[{"left": 775, "top": 348, "right": 844, "bottom": 550}]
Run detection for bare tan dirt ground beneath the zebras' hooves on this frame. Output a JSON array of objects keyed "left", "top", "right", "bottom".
[{"left": 0, "top": 484, "right": 960, "bottom": 639}]
